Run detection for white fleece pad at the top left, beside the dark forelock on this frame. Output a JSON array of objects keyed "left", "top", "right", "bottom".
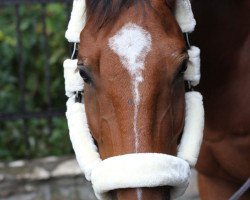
[{"left": 65, "top": 0, "right": 86, "bottom": 42}]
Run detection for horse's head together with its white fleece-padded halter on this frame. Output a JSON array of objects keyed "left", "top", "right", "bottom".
[{"left": 64, "top": 0, "right": 204, "bottom": 200}]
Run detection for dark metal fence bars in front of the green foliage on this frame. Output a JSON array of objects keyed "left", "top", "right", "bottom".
[{"left": 0, "top": 0, "right": 72, "bottom": 159}]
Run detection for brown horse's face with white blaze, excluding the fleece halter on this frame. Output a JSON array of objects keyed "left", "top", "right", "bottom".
[{"left": 78, "top": 0, "right": 188, "bottom": 200}]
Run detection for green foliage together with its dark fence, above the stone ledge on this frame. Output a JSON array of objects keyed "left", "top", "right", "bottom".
[{"left": 0, "top": 0, "right": 72, "bottom": 161}]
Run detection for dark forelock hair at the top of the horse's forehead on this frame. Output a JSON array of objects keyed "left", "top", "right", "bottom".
[{"left": 86, "top": 0, "right": 174, "bottom": 30}]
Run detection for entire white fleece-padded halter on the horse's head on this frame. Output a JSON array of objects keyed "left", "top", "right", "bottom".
[{"left": 64, "top": 0, "right": 204, "bottom": 200}]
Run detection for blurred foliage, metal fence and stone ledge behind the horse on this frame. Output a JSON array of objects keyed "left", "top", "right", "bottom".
[{"left": 0, "top": 0, "right": 198, "bottom": 200}]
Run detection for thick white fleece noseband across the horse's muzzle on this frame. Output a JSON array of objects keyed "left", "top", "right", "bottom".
[{"left": 91, "top": 153, "right": 190, "bottom": 200}]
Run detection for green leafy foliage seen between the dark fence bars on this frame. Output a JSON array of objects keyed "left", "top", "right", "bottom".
[{"left": 0, "top": 4, "right": 72, "bottom": 160}]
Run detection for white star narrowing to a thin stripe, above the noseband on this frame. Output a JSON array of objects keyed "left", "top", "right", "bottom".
[{"left": 109, "top": 23, "right": 152, "bottom": 152}]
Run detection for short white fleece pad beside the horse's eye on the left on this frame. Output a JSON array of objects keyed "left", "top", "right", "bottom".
[{"left": 63, "top": 59, "right": 84, "bottom": 97}]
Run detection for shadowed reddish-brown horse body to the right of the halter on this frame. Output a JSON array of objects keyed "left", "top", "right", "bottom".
[{"left": 192, "top": 0, "right": 250, "bottom": 200}]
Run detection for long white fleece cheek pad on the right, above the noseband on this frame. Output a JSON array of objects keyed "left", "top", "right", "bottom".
[{"left": 177, "top": 91, "right": 204, "bottom": 166}]
